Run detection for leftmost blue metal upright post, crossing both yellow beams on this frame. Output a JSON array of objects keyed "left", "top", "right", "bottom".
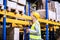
[{"left": 3, "top": 0, "right": 7, "bottom": 40}]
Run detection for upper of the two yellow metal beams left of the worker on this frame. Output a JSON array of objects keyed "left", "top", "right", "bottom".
[{"left": 0, "top": 11, "right": 32, "bottom": 20}]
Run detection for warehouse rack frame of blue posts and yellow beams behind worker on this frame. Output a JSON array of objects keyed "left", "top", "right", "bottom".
[{"left": 0, "top": 0, "right": 60, "bottom": 40}]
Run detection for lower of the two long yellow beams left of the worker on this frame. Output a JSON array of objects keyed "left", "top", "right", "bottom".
[{"left": 0, "top": 18, "right": 29, "bottom": 25}]
